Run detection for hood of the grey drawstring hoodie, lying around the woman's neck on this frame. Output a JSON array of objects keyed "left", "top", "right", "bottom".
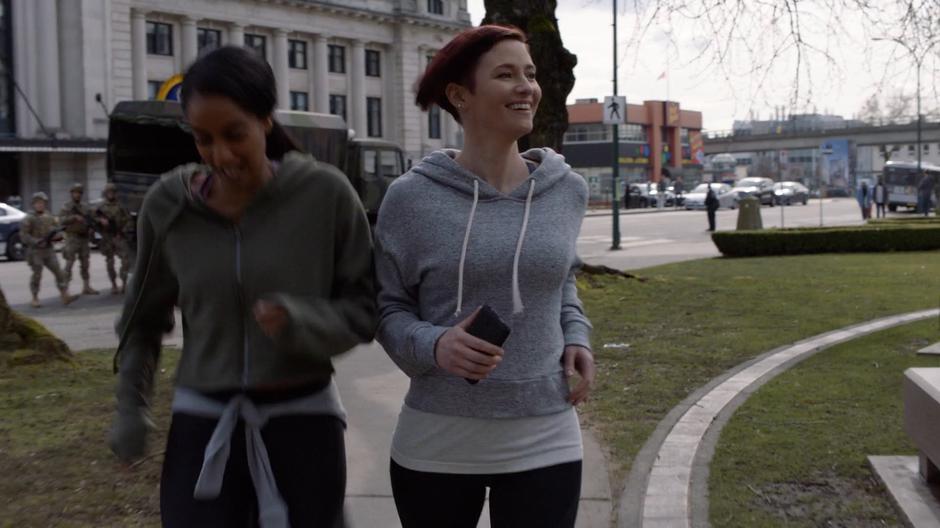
[{"left": 411, "top": 148, "right": 571, "bottom": 200}]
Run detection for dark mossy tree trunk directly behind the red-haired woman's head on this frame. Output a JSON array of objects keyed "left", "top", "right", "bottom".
[{"left": 483, "top": 0, "right": 578, "bottom": 152}]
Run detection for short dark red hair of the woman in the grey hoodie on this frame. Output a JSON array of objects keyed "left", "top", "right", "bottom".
[{"left": 415, "top": 25, "right": 528, "bottom": 123}]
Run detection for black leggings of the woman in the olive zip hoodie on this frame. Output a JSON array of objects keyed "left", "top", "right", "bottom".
[{"left": 160, "top": 413, "right": 346, "bottom": 528}]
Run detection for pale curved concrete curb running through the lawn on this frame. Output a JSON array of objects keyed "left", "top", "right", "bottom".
[{"left": 618, "top": 309, "right": 940, "bottom": 528}]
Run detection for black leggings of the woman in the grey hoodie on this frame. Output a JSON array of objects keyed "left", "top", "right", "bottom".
[{"left": 391, "top": 460, "right": 581, "bottom": 528}]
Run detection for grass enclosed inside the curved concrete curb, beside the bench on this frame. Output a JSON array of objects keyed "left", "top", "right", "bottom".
[{"left": 709, "top": 319, "right": 940, "bottom": 528}]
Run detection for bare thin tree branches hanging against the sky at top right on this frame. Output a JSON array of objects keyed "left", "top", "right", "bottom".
[{"left": 616, "top": 0, "right": 940, "bottom": 117}]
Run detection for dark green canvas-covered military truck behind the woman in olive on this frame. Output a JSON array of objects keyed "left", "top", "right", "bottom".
[{"left": 108, "top": 101, "right": 404, "bottom": 223}]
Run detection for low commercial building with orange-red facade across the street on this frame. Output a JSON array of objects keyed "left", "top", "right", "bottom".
[{"left": 564, "top": 99, "right": 704, "bottom": 201}]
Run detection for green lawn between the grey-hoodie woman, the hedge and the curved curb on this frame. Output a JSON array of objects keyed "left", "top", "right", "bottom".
[{"left": 579, "top": 251, "right": 940, "bottom": 490}]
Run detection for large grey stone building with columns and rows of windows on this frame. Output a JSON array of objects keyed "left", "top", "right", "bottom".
[{"left": 0, "top": 0, "right": 471, "bottom": 208}]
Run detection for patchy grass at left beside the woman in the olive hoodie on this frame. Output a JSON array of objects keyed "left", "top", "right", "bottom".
[{"left": 0, "top": 350, "right": 179, "bottom": 528}]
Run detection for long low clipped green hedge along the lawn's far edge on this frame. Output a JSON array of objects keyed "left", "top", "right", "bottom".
[{"left": 712, "top": 222, "right": 940, "bottom": 257}]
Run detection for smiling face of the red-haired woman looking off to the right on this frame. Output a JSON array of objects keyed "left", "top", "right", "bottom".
[{"left": 451, "top": 40, "right": 542, "bottom": 141}]
